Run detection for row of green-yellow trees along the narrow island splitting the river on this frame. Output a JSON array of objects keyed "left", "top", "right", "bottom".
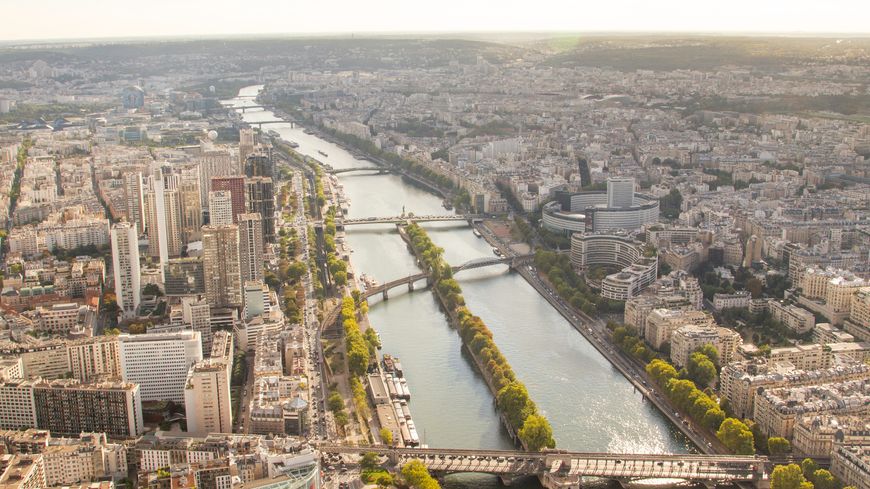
[{"left": 406, "top": 223, "right": 556, "bottom": 451}]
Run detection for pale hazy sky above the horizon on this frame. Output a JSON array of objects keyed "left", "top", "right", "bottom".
[{"left": 0, "top": 0, "right": 870, "bottom": 40}]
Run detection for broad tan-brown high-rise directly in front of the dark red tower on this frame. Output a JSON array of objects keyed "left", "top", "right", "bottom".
[{"left": 202, "top": 224, "right": 242, "bottom": 308}]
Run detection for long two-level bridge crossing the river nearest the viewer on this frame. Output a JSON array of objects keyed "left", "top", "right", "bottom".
[{"left": 318, "top": 445, "right": 770, "bottom": 489}]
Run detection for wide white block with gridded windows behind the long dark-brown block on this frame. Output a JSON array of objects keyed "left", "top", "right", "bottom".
[{"left": 118, "top": 331, "right": 202, "bottom": 402}]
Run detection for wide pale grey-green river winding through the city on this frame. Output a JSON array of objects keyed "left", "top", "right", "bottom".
[{"left": 232, "top": 86, "right": 693, "bottom": 487}]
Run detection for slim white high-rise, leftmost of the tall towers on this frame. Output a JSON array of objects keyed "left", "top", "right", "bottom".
[{"left": 111, "top": 222, "right": 141, "bottom": 317}]
